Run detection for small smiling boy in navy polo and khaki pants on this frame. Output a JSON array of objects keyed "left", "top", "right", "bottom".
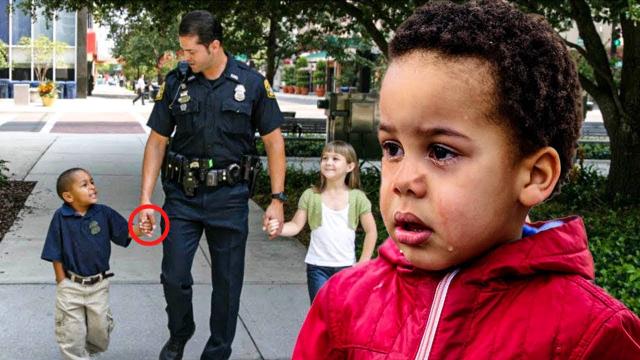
[{"left": 42, "top": 168, "right": 151, "bottom": 360}]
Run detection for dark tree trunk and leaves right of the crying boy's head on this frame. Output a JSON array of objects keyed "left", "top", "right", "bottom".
[{"left": 517, "top": 0, "right": 640, "bottom": 204}]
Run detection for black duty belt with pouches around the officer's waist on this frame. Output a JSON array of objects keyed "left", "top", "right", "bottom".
[{"left": 162, "top": 151, "right": 260, "bottom": 196}]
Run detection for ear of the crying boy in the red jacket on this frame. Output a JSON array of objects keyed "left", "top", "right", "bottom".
[{"left": 518, "top": 146, "right": 560, "bottom": 207}]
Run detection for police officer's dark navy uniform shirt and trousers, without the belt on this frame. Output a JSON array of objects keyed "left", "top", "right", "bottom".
[{"left": 147, "top": 54, "right": 283, "bottom": 359}]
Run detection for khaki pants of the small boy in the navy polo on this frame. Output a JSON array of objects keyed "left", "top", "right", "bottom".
[{"left": 56, "top": 279, "right": 113, "bottom": 360}]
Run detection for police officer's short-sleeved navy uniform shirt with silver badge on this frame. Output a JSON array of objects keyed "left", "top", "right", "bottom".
[{"left": 147, "top": 53, "right": 284, "bottom": 168}]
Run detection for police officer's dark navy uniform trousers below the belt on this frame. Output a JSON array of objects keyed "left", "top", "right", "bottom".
[{"left": 161, "top": 184, "right": 249, "bottom": 360}]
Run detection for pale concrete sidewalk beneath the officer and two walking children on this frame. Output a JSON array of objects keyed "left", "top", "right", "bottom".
[{"left": 0, "top": 132, "right": 309, "bottom": 360}]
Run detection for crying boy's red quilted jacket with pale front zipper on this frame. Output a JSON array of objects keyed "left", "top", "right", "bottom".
[{"left": 293, "top": 217, "right": 640, "bottom": 360}]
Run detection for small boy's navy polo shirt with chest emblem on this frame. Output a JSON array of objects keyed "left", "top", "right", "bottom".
[{"left": 41, "top": 204, "right": 131, "bottom": 276}]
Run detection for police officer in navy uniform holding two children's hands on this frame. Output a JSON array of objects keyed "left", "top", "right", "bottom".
[{"left": 140, "top": 11, "right": 286, "bottom": 359}]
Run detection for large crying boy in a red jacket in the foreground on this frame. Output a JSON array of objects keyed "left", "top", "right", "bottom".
[{"left": 293, "top": 1, "right": 640, "bottom": 360}]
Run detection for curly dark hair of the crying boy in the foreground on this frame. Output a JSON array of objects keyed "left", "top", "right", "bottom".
[{"left": 389, "top": 0, "right": 582, "bottom": 190}]
